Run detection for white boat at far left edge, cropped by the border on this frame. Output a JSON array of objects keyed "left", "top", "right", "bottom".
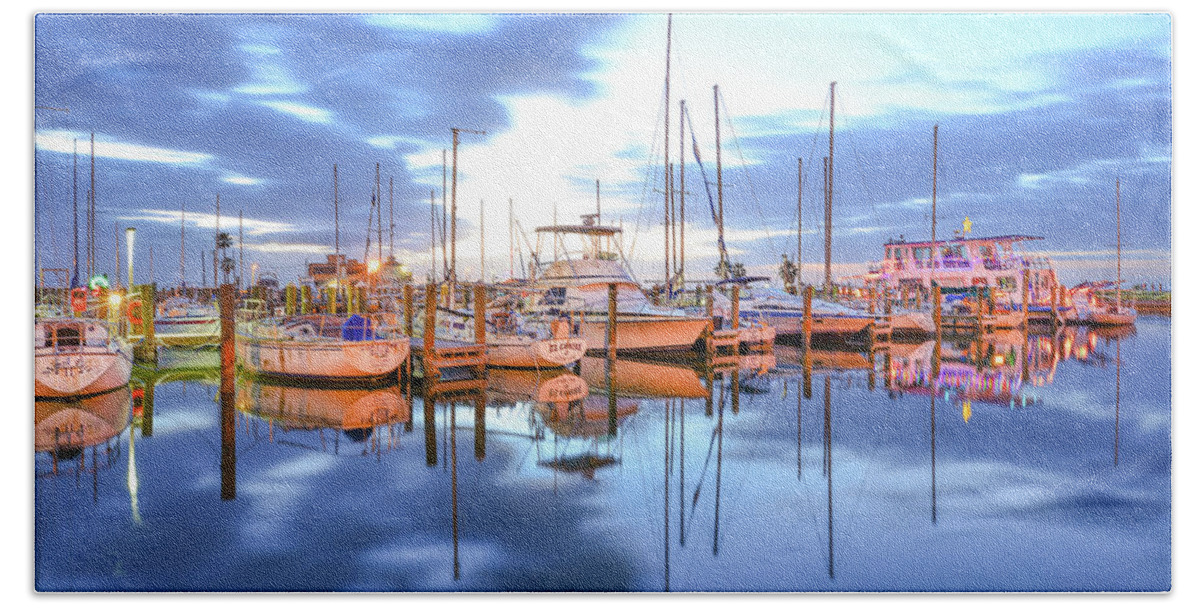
[{"left": 34, "top": 317, "right": 133, "bottom": 398}]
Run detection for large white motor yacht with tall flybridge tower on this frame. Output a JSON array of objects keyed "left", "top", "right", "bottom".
[{"left": 527, "top": 215, "right": 709, "bottom": 354}]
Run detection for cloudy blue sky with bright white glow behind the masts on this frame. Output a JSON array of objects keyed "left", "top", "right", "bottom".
[{"left": 34, "top": 13, "right": 1174, "bottom": 290}]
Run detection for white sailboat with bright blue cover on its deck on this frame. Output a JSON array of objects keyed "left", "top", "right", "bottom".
[{"left": 236, "top": 311, "right": 410, "bottom": 381}]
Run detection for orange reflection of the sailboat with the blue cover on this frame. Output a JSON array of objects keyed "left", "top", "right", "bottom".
[{"left": 236, "top": 378, "right": 412, "bottom": 455}]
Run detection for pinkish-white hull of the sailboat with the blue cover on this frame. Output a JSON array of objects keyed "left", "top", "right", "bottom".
[{"left": 236, "top": 336, "right": 410, "bottom": 380}]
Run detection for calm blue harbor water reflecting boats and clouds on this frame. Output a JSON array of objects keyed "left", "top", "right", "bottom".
[{"left": 35, "top": 317, "right": 1171, "bottom": 591}]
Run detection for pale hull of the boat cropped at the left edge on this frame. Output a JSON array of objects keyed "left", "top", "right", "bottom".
[{"left": 34, "top": 345, "right": 133, "bottom": 398}]
